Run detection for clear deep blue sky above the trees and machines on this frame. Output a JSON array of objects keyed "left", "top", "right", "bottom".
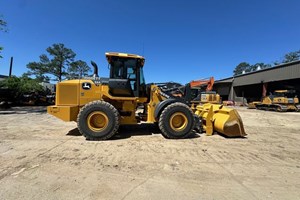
[{"left": 0, "top": 0, "right": 300, "bottom": 84}]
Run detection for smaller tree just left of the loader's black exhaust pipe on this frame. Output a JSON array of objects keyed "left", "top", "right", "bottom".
[{"left": 66, "top": 60, "right": 91, "bottom": 79}]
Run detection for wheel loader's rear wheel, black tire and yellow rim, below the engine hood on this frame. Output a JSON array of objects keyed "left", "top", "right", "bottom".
[{"left": 77, "top": 101, "right": 120, "bottom": 140}]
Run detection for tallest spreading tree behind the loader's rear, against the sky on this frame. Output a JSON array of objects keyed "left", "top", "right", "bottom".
[{"left": 27, "top": 43, "right": 76, "bottom": 82}]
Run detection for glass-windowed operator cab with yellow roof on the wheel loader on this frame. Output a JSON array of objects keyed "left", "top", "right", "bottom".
[{"left": 106, "top": 53, "right": 146, "bottom": 97}]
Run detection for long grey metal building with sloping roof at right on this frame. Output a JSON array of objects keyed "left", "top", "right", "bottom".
[{"left": 214, "top": 61, "right": 300, "bottom": 102}]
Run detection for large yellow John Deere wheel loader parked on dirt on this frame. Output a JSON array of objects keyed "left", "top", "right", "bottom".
[{"left": 47, "top": 52, "right": 246, "bottom": 140}]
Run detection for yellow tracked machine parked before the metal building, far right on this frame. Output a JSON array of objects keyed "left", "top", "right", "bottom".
[{"left": 251, "top": 90, "right": 300, "bottom": 112}]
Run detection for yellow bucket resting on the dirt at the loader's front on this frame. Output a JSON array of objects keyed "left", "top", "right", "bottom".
[{"left": 195, "top": 103, "right": 247, "bottom": 137}]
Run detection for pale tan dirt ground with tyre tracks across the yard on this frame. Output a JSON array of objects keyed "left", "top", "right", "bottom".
[{"left": 0, "top": 107, "right": 300, "bottom": 200}]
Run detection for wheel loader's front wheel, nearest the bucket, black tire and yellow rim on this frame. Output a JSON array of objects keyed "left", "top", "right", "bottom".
[{"left": 158, "top": 102, "right": 195, "bottom": 139}]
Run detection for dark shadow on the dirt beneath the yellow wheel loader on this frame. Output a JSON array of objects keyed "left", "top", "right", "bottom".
[{"left": 67, "top": 124, "right": 200, "bottom": 140}]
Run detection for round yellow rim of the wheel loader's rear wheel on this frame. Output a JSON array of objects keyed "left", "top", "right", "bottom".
[{"left": 87, "top": 111, "right": 108, "bottom": 132}]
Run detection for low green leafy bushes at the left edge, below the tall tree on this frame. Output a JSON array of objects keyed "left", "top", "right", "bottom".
[{"left": 0, "top": 75, "right": 44, "bottom": 98}]
